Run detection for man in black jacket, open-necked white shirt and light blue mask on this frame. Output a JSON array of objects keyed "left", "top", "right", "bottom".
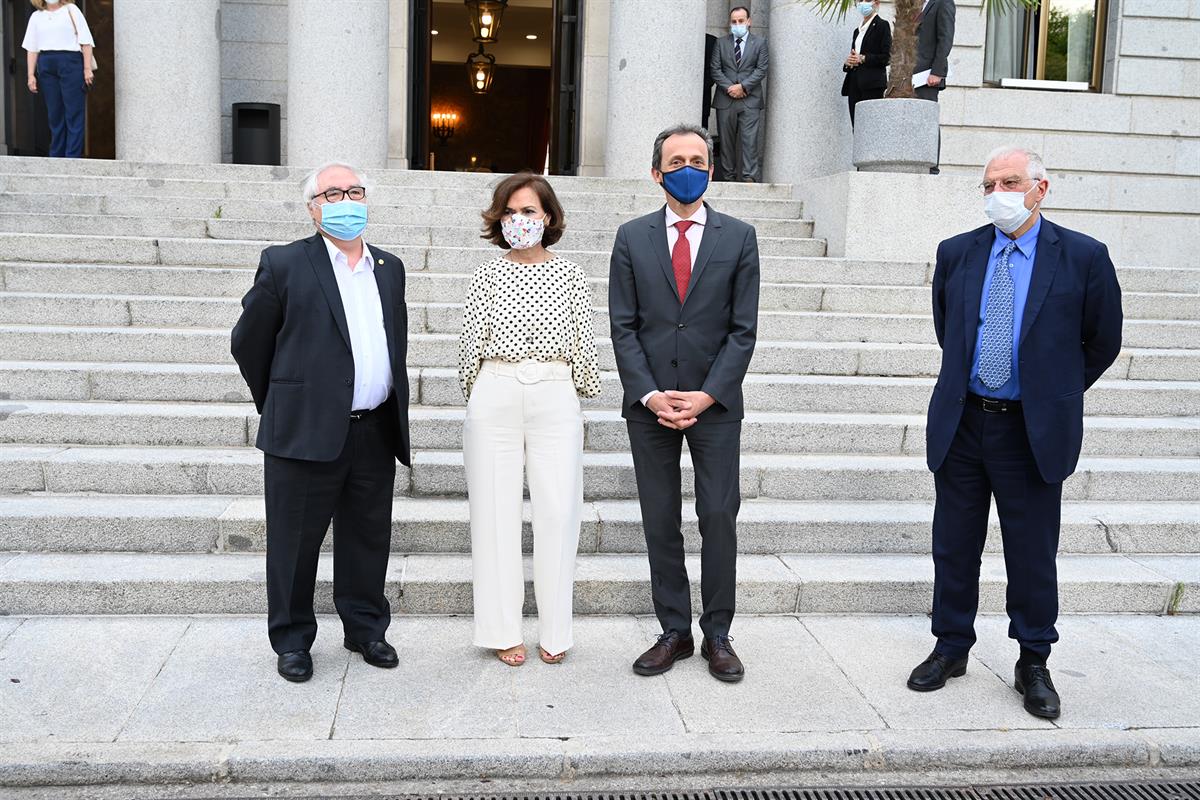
[{"left": 233, "top": 164, "right": 409, "bottom": 681}]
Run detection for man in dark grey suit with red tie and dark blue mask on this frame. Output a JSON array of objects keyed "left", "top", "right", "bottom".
[{"left": 608, "top": 125, "right": 758, "bottom": 681}]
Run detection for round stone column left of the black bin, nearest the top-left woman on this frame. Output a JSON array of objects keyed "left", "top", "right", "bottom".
[{"left": 113, "top": 0, "right": 221, "bottom": 164}]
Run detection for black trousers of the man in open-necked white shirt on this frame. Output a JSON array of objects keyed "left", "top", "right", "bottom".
[{"left": 264, "top": 414, "right": 396, "bottom": 652}]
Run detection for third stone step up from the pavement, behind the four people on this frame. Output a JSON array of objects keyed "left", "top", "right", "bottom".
[{"left": 0, "top": 445, "right": 1200, "bottom": 503}]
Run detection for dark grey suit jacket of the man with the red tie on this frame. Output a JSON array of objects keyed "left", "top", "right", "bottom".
[{"left": 608, "top": 204, "right": 758, "bottom": 425}]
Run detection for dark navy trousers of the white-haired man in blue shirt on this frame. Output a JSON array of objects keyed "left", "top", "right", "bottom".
[{"left": 932, "top": 405, "right": 1062, "bottom": 658}]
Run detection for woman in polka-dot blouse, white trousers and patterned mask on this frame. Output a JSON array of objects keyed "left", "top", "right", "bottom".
[{"left": 458, "top": 173, "right": 600, "bottom": 667}]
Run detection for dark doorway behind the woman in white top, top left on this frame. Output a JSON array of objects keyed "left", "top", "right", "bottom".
[{"left": 2, "top": 0, "right": 116, "bottom": 158}]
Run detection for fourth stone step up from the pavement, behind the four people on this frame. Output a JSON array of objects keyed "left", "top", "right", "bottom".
[{"left": 0, "top": 401, "right": 1200, "bottom": 458}]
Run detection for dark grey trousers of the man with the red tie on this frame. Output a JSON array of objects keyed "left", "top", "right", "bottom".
[{"left": 629, "top": 422, "right": 742, "bottom": 637}]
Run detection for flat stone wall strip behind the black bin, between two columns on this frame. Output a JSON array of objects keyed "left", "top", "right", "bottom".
[{"left": 221, "top": 0, "right": 288, "bottom": 164}]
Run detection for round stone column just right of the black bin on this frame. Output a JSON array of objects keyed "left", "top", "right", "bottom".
[{"left": 286, "top": 0, "right": 389, "bottom": 169}]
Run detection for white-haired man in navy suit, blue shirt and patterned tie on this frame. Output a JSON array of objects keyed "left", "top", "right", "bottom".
[{"left": 908, "top": 148, "right": 1122, "bottom": 720}]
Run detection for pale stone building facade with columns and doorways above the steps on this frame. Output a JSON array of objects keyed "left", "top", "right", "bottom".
[{"left": 4, "top": 0, "right": 1200, "bottom": 263}]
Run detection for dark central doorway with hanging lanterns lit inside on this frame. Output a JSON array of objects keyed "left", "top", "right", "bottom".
[{"left": 409, "top": 0, "right": 583, "bottom": 174}]
